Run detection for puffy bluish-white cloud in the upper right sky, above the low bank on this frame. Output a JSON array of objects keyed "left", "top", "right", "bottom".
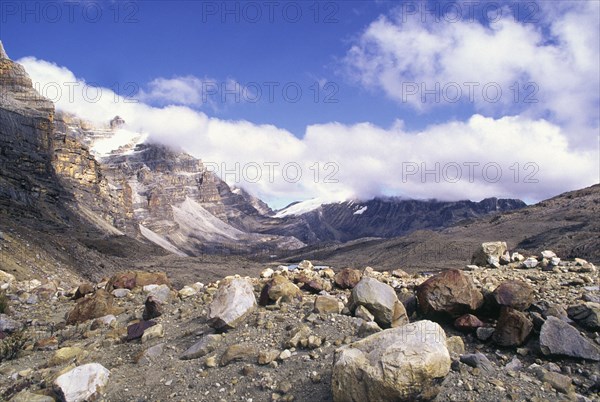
[{"left": 345, "top": 1, "right": 600, "bottom": 148}]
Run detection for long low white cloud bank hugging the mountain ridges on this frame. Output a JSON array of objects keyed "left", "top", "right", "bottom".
[{"left": 19, "top": 38, "right": 600, "bottom": 207}]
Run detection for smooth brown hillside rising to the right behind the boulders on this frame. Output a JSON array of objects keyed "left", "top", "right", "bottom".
[{"left": 287, "top": 184, "right": 600, "bottom": 270}]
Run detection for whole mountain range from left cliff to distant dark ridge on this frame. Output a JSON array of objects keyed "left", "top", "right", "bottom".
[{"left": 0, "top": 44, "right": 536, "bottom": 276}]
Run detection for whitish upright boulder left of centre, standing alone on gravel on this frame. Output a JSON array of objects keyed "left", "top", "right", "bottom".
[{"left": 208, "top": 278, "right": 256, "bottom": 330}]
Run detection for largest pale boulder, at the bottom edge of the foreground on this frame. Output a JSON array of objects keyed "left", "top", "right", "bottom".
[{"left": 331, "top": 321, "right": 450, "bottom": 402}]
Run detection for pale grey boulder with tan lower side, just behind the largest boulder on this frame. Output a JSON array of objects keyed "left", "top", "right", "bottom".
[{"left": 348, "top": 277, "right": 408, "bottom": 328}]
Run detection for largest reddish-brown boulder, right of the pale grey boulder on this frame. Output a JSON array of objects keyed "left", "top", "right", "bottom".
[{"left": 417, "top": 269, "right": 483, "bottom": 317}]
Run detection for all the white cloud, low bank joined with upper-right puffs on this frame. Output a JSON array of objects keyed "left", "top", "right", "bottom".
[{"left": 18, "top": 2, "right": 600, "bottom": 207}]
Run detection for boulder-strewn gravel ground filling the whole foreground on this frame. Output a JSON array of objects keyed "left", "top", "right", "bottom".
[{"left": 0, "top": 247, "right": 600, "bottom": 401}]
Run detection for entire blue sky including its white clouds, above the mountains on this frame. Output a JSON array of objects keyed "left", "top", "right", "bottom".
[{"left": 0, "top": 1, "right": 600, "bottom": 205}]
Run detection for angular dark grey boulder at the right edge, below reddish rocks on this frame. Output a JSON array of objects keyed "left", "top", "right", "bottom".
[{"left": 540, "top": 317, "right": 600, "bottom": 361}]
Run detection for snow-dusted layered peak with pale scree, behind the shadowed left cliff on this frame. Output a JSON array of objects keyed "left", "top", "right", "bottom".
[{"left": 52, "top": 114, "right": 304, "bottom": 256}]
